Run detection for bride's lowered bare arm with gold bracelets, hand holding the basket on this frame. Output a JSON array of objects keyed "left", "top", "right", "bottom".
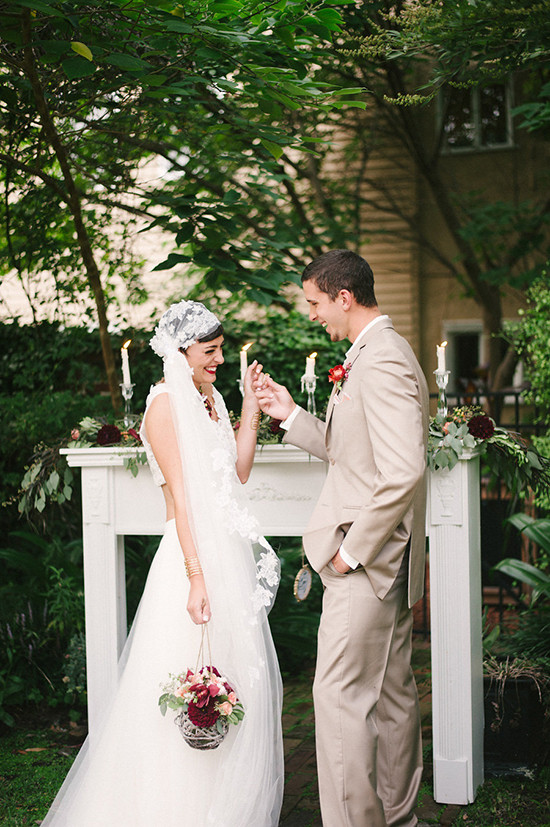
[{"left": 146, "top": 393, "right": 210, "bottom": 623}]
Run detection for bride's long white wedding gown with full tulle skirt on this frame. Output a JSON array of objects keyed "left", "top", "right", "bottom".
[{"left": 42, "top": 385, "right": 283, "bottom": 827}]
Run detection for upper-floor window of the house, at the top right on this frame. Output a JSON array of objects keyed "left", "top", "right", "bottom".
[{"left": 439, "top": 81, "right": 512, "bottom": 152}]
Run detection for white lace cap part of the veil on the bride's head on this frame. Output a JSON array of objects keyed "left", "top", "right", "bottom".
[{"left": 150, "top": 299, "right": 220, "bottom": 359}]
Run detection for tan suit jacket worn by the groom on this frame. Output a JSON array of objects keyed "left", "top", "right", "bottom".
[{"left": 284, "top": 318, "right": 429, "bottom": 606}]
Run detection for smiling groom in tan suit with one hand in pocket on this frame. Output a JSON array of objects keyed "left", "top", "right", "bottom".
[{"left": 257, "top": 250, "right": 428, "bottom": 827}]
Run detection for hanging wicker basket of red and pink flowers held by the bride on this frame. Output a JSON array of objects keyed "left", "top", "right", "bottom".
[{"left": 159, "top": 623, "right": 244, "bottom": 750}]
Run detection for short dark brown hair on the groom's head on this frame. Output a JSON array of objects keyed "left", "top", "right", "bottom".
[{"left": 302, "top": 250, "right": 377, "bottom": 307}]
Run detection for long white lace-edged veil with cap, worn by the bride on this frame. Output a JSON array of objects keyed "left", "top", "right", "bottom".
[{"left": 151, "top": 301, "right": 280, "bottom": 613}]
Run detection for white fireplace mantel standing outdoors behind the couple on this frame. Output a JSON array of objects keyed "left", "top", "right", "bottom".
[{"left": 63, "top": 445, "right": 483, "bottom": 804}]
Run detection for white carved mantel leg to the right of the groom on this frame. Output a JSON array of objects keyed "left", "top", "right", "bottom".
[{"left": 428, "top": 456, "right": 484, "bottom": 804}]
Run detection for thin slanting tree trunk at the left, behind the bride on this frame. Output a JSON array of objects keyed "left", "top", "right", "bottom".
[{"left": 22, "top": 11, "right": 122, "bottom": 414}]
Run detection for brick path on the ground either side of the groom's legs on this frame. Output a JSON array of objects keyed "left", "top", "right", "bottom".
[{"left": 279, "top": 640, "right": 461, "bottom": 827}]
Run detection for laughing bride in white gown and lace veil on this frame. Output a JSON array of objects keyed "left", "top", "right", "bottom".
[{"left": 42, "top": 301, "right": 283, "bottom": 827}]
